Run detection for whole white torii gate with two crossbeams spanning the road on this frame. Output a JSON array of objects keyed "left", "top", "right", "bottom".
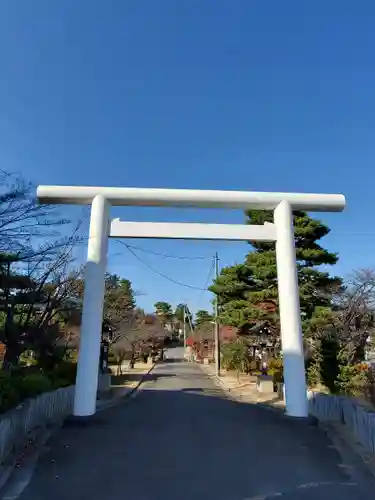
[{"left": 37, "top": 186, "right": 345, "bottom": 417}]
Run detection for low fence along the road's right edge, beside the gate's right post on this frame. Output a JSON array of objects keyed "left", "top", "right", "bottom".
[{"left": 308, "top": 392, "right": 375, "bottom": 453}]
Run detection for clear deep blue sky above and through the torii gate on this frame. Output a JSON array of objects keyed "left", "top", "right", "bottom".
[{"left": 0, "top": 0, "right": 375, "bottom": 309}]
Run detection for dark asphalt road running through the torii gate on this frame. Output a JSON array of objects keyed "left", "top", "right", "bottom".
[{"left": 10, "top": 350, "right": 375, "bottom": 500}]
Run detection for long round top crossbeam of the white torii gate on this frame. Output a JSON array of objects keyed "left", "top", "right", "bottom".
[{"left": 37, "top": 186, "right": 345, "bottom": 212}]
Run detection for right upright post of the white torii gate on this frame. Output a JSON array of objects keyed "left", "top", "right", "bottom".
[{"left": 274, "top": 200, "right": 308, "bottom": 417}]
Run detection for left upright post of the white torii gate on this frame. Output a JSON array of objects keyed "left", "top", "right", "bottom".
[{"left": 73, "top": 195, "right": 109, "bottom": 417}]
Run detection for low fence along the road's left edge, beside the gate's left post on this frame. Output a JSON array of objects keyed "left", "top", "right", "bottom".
[{"left": 0, "top": 385, "right": 74, "bottom": 464}]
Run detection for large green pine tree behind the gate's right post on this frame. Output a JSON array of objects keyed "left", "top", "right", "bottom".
[{"left": 211, "top": 210, "right": 341, "bottom": 328}]
